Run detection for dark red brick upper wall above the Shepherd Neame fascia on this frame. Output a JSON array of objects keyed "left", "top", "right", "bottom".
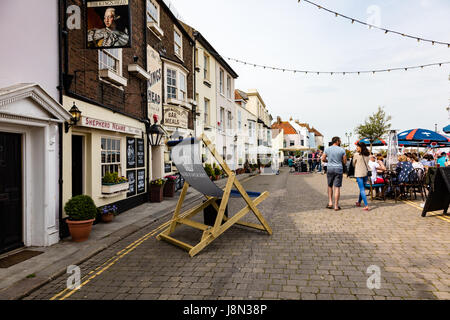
[{"left": 61, "top": 0, "right": 147, "bottom": 119}]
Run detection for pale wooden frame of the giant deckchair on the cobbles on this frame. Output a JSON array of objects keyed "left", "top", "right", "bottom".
[{"left": 157, "top": 134, "right": 272, "bottom": 257}]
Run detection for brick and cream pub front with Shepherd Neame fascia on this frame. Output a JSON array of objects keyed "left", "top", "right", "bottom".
[{"left": 59, "top": 0, "right": 151, "bottom": 235}]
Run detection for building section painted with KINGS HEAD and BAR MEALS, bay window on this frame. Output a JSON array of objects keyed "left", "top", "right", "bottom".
[{"left": 146, "top": 0, "right": 197, "bottom": 178}]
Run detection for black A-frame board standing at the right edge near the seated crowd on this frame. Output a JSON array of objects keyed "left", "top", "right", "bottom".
[{"left": 422, "top": 167, "right": 450, "bottom": 217}]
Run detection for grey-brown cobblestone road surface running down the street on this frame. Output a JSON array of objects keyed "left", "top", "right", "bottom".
[{"left": 25, "top": 169, "right": 450, "bottom": 300}]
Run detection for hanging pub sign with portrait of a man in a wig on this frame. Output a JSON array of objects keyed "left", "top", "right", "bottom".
[{"left": 86, "top": 0, "right": 131, "bottom": 49}]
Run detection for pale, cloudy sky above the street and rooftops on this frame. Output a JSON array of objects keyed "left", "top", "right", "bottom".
[{"left": 165, "top": 0, "right": 450, "bottom": 142}]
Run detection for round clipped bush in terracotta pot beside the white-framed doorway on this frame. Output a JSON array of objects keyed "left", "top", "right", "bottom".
[{"left": 64, "top": 195, "right": 97, "bottom": 242}]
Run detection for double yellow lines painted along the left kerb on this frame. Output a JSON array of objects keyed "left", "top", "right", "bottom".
[{"left": 50, "top": 176, "right": 256, "bottom": 300}]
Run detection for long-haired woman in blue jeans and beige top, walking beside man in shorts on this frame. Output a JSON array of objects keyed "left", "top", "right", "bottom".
[{"left": 353, "top": 142, "right": 370, "bottom": 211}]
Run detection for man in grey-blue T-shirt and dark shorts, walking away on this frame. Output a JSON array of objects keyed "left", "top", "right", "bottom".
[{"left": 322, "top": 137, "right": 347, "bottom": 211}]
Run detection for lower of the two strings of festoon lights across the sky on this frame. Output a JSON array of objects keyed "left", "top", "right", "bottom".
[{"left": 219, "top": 55, "right": 450, "bottom": 76}]
